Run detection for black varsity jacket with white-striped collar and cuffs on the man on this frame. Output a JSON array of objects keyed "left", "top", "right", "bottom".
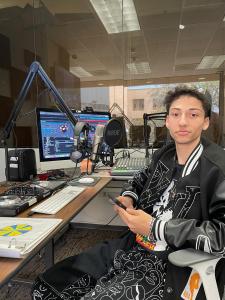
[{"left": 121, "top": 140, "right": 225, "bottom": 300}]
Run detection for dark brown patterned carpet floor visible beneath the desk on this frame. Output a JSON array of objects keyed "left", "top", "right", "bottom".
[{"left": 0, "top": 229, "right": 121, "bottom": 300}]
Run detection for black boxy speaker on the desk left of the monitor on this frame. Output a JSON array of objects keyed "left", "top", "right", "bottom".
[{"left": 6, "top": 149, "right": 37, "bottom": 181}]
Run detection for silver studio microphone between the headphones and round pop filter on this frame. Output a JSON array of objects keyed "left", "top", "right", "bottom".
[{"left": 90, "top": 124, "right": 105, "bottom": 172}]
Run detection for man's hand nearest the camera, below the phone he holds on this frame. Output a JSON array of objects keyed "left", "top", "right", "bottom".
[{"left": 116, "top": 206, "right": 152, "bottom": 236}]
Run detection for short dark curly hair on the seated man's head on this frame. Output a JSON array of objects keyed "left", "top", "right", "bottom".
[{"left": 164, "top": 86, "right": 211, "bottom": 118}]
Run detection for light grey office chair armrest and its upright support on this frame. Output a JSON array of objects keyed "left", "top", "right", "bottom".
[{"left": 168, "top": 249, "right": 222, "bottom": 300}]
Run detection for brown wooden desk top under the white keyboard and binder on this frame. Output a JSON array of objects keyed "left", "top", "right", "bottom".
[{"left": 0, "top": 177, "right": 111, "bottom": 287}]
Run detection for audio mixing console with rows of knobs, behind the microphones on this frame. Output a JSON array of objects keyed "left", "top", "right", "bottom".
[{"left": 111, "top": 157, "right": 149, "bottom": 176}]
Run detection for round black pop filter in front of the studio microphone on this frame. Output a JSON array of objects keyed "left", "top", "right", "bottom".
[{"left": 103, "top": 119, "right": 123, "bottom": 148}]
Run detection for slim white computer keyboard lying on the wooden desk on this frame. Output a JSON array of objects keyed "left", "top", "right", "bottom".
[{"left": 31, "top": 186, "right": 85, "bottom": 215}]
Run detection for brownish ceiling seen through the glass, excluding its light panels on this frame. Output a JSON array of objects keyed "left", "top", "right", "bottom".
[{"left": 0, "top": 0, "right": 225, "bottom": 85}]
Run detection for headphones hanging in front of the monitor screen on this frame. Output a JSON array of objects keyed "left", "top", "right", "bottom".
[{"left": 70, "top": 122, "right": 89, "bottom": 163}]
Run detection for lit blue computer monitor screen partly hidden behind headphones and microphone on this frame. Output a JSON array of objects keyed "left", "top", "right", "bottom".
[{"left": 37, "top": 108, "right": 110, "bottom": 161}]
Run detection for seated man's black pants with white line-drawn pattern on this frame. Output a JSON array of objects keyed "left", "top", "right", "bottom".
[{"left": 32, "top": 234, "right": 166, "bottom": 300}]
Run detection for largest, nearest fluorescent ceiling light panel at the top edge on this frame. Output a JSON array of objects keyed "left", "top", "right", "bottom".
[{"left": 90, "top": 0, "right": 140, "bottom": 34}]
